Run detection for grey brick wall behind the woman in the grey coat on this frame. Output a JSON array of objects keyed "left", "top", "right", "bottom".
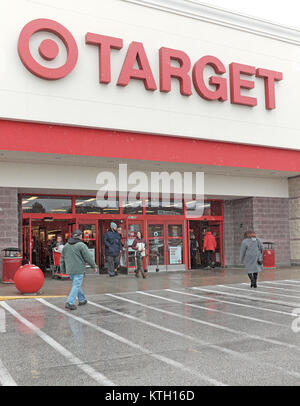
[{"left": 224, "top": 198, "right": 291, "bottom": 266}]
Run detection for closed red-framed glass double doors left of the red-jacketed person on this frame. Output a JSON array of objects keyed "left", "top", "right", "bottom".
[{"left": 148, "top": 221, "right": 185, "bottom": 272}]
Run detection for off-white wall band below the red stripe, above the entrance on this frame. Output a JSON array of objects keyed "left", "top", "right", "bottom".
[{"left": 0, "top": 162, "right": 288, "bottom": 198}]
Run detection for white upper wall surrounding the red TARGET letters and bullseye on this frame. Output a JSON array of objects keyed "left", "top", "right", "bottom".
[{"left": 0, "top": 0, "right": 300, "bottom": 151}]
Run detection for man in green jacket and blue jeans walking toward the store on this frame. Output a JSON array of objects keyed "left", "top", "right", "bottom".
[{"left": 60, "top": 230, "right": 98, "bottom": 310}]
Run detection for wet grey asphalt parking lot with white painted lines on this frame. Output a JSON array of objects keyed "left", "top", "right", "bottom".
[{"left": 0, "top": 279, "right": 300, "bottom": 386}]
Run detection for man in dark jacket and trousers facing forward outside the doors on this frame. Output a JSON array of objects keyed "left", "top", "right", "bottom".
[{"left": 103, "top": 222, "right": 122, "bottom": 276}]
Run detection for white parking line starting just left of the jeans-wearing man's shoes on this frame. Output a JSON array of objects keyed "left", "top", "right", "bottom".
[{"left": 36, "top": 299, "right": 227, "bottom": 386}]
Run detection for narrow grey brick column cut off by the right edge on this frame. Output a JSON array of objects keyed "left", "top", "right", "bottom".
[{"left": 289, "top": 176, "right": 300, "bottom": 265}]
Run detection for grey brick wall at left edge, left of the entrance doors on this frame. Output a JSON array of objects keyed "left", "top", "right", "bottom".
[{"left": 0, "top": 187, "right": 21, "bottom": 280}]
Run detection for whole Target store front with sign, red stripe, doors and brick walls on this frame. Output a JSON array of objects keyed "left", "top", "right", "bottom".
[{"left": 0, "top": 0, "right": 300, "bottom": 272}]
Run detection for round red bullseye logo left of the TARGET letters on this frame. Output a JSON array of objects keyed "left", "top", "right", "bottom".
[{"left": 18, "top": 18, "right": 78, "bottom": 80}]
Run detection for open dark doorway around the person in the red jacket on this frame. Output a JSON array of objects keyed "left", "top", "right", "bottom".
[{"left": 188, "top": 220, "right": 223, "bottom": 269}]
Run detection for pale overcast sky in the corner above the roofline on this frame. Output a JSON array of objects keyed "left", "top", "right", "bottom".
[{"left": 198, "top": 0, "right": 300, "bottom": 29}]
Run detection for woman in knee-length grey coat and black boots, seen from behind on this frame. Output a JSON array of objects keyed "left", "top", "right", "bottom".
[{"left": 240, "top": 231, "right": 264, "bottom": 288}]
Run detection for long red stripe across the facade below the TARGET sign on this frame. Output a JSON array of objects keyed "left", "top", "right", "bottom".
[{"left": 0, "top": 120, "right": 300, "bottom": 172}]
